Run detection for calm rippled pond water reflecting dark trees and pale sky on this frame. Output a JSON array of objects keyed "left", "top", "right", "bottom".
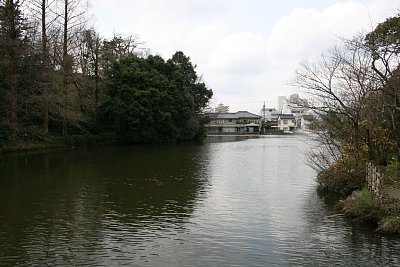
[{"left": 0, "top": 136, "right": 400, "bottom": 266}]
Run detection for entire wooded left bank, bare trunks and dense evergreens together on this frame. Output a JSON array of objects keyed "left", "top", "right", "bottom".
[{"left": 0, "top": 0, "right": 212, "bottom": 147}]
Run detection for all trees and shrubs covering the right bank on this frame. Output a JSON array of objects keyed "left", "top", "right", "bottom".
[{"left": 293, "top": 15, "right": 400, "bottom": 233}]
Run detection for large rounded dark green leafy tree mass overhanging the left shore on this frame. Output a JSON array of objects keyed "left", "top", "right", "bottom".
[{"left": 98, "top": 52, "right": 212, "bottom": 143}]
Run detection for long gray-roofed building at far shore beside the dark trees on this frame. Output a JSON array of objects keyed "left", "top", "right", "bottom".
[{"left": 206, "top": 111, "right": 261, "bottom": 134}]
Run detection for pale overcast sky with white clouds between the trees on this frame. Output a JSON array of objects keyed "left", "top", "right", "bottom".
[{"left": 91, "top": 0, "right": 400, "bottom": 113}]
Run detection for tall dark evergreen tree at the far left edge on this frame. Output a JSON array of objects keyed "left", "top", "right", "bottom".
[{"left": 0, "top": 0, "right": 32, "bottom": 140}]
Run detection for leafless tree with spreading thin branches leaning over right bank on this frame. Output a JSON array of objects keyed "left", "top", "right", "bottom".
[{"left": 293, "top": 38, "right": 379, "bottom": 168}]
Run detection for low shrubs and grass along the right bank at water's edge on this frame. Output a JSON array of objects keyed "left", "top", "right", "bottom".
[{"left": 317, "top": 159, "right": 400, "bottom": 234}]
